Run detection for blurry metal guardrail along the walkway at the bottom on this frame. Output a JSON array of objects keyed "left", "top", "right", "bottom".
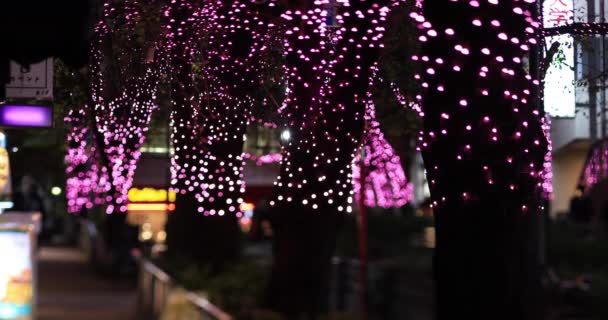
[{"left": 137, "top": 258, "right": 232, "bottom": 320}]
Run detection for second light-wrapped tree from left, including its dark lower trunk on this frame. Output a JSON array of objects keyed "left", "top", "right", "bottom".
[{"left": 166, "top": 1, "right": 274, "bottom": 260}]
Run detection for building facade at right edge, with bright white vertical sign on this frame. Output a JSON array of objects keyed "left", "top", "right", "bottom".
[{"left": 543, "top": 0, "right": 608, "bottom": 217}]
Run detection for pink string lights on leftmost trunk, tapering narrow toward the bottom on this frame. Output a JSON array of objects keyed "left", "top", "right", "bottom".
[{"left": 90, "top": 1, "right": 160, "bottom": 213}]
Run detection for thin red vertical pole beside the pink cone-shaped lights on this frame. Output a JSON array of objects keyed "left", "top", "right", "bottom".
[{"left": 357, "top": 147, "right": 368, "bottom": 320}]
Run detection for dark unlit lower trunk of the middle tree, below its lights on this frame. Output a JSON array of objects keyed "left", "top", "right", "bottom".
[{"left": 266, "top": 205, "right": 342, "bottom": 319}]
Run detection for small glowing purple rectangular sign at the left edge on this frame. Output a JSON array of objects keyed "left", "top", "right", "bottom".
[{"left": 0, "top": 105, "right": 53, "bottom": 128}]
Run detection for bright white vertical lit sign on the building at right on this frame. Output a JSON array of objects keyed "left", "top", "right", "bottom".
[{"left": 543, "top": 0, "right": 576, "bottom": 117}]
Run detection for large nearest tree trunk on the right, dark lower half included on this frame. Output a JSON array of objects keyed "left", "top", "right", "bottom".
[{"left": 419, "top": 0, "right": 546, "bottom": 320}]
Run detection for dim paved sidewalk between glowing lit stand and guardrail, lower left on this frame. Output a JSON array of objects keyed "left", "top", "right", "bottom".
[{"left": 35, "top": 247, "right": 136, "bottom": 320}]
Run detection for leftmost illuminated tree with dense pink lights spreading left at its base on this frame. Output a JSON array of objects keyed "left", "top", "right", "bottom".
[{"left": 66, "top": 1, "right": 161, "bottom": 213}]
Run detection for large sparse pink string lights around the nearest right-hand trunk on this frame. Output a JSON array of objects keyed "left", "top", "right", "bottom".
[{"left": 410, "top": 0, "right": 547, "bottom": 212}]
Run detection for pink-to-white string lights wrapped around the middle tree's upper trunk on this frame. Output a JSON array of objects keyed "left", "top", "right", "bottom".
[{"left": 270, "top": 0, "right": 394, "bottom": 212}]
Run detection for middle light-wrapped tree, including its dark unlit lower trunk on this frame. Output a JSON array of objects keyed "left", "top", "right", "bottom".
[{"left": 268, "top": 0, "right": 392, "bottom": 315}]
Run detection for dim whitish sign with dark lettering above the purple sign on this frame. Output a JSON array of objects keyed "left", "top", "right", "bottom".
[{"left": 6, "top": 58, "right": 53, "bottom": 99}]
